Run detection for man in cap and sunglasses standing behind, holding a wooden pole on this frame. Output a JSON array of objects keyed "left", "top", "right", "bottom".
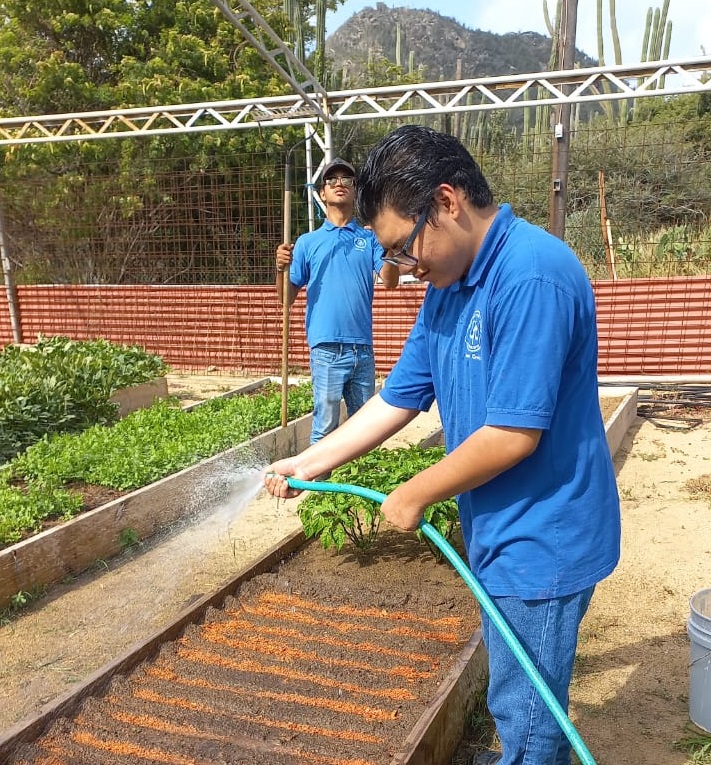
[{"left": 276, "top": 157, "right": 400, "bottom": 444}]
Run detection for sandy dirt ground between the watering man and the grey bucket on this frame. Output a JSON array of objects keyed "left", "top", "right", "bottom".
[{"left": 571, "top": 412, "right": 711, "bottom": 765}]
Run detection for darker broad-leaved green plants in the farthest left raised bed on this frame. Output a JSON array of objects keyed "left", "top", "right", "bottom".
[{"left": 0, "top": 336, "right": 168, "bottom": 464}]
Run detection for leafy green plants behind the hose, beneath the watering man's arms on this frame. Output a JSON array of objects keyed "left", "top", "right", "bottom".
[{"left": 298, "top": 445, "right": 458, "bottom": 560}]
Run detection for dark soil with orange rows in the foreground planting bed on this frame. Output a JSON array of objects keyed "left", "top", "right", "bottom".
[{"left": 5, "top": 530, "right": 478, "bottom": 765}]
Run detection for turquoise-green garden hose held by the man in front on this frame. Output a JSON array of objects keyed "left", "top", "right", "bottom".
[{"left": 286, "top": 476, "right": 596, "bottom": 765}]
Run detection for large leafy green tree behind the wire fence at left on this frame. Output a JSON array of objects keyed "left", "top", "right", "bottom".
[{"left": 0, "top": 0, "right": 312, "bottom": 283}]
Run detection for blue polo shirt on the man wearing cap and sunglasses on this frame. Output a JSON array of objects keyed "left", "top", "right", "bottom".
[{"left": 289, "top": 219, "right": 383, "bottom": 348}]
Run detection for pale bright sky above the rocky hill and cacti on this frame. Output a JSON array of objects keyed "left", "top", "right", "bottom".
[{"left": 326, "top": 0, "right": 711, "bottom": 65}]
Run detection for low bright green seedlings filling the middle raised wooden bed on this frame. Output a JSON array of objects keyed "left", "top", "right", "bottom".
[{"left": 0, "top": 384, "right": 312, "bottom": 544}]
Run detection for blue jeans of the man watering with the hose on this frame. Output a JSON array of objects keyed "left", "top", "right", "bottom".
[{"left": 481, "top": 587, "right": 595, "bottom": 765}]
